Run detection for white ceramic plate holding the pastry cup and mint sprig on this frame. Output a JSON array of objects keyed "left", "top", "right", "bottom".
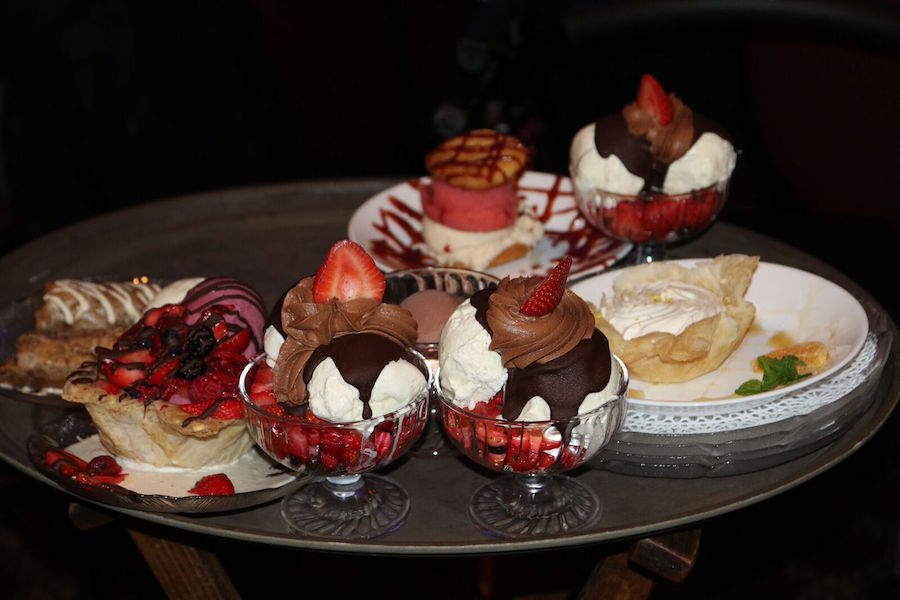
[{"left": 572, "top": 260, "right": 869, "bottom": 414}]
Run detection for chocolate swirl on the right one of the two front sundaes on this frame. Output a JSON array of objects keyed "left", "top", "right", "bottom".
[{"left": 487, "top": 277, "right": 594, "bottom": 369}]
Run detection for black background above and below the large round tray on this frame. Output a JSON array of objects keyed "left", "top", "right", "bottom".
[{"left": 0, "top": 0, "right": 900, "bottom": 598}]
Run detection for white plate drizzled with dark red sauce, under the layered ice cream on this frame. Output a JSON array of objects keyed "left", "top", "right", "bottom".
[{"left": 348, "top": 171, "right": 631, "bottom": 278}]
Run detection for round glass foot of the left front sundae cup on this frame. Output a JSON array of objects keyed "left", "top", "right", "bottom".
[{"left": 281, "top": 474, "right": 410, "bottom": 540}]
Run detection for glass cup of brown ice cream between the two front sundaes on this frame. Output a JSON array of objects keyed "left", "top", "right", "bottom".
[{"left": 383, "top": 267, "right": 499, "bottom": 457}]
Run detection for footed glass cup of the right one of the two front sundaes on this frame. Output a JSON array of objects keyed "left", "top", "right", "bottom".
[{"left": 438, "top": 358, "right": 628, "bottom": 538}]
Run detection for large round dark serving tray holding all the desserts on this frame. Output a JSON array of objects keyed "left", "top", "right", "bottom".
[{"left": 0, "top": 179, "right": 900, "bottom": 556}]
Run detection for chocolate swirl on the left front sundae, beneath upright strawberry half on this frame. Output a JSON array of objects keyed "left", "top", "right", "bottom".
[{"left": 273, "top": 277, "right": 417, "bottom": 404}]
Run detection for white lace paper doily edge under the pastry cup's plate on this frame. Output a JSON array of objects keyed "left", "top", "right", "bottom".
[{"left": 621, "top": 332, "right": 878, "bottom": 435}]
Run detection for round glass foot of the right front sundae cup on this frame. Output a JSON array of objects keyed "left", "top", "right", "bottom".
[{"left": 469, "top": 475, "right": 600, "bottom": 538}]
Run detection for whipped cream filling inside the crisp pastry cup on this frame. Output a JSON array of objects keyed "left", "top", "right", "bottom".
[{"left": 600, "top": 281, "right": 725, "bottom": 340}]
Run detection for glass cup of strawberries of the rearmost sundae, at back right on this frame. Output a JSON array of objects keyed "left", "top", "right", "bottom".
[{"left": 575, "top": 179, "right": 729, "bottom": 264}]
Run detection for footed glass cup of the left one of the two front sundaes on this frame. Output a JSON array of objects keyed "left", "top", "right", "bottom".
[{"left": 239, "top": 356, "right": 431, "bottom": 540}]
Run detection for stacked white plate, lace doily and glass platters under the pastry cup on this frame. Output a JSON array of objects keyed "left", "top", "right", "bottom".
[{"left": 573, "top": 259, "right": 892, "bottom": 477}]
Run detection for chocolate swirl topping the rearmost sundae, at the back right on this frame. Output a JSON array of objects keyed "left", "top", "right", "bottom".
[{"left": 622, "top": 94, "right": 694, "bottom": 164}]
